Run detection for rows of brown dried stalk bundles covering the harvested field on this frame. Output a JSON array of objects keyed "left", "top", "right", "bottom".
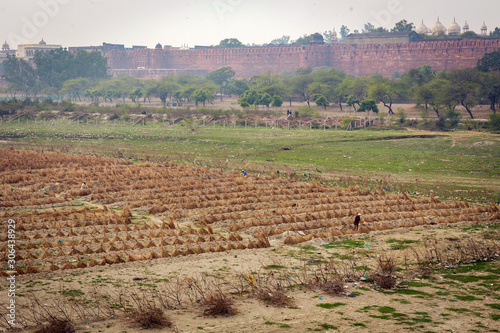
[{"left": 0, "top": 149, "right": 500, "bottom": 275}]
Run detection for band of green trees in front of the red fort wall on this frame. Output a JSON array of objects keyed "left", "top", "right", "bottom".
[{"left": 3, "top": 49, "right": 500, "bottom": 118}]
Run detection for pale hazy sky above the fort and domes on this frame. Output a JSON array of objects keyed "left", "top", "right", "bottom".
[{"left": 0, "top": 0, "right": 500, "bottom": 49}]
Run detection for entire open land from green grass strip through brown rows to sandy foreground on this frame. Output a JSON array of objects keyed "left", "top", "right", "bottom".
[{"left": 0, "top": 121, "right": 500, "bottom": 333}]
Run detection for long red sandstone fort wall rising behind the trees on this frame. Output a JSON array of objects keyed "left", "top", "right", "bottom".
[{"left": 108, "top": 39, "right": 500, "bottom": 78}]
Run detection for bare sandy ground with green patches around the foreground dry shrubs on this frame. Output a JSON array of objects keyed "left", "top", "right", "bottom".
[{"left": 0, "top": 220, "right": 500, "bottom": 333}]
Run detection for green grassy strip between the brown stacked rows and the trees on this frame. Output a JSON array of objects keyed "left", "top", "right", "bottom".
[{"left": 0, "top": 120, "right": 500, "bottom": 202}]
